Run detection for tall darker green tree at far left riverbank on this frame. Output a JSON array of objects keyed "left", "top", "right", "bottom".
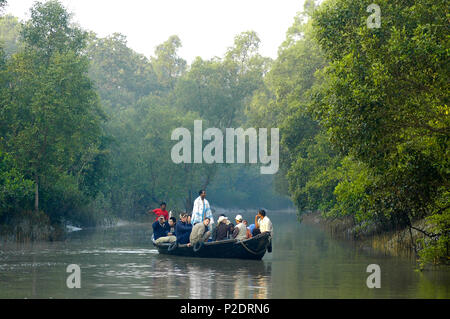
[{"left": 0, "top": 2, "right": 103, "bottom": 228}]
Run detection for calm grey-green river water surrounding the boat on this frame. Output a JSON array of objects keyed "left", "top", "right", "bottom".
[{"left": 0, "top": 212, "right": 450, "bottom": 298}]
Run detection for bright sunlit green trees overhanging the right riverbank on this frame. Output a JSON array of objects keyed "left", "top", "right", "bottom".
[{"left": 313, "top": 1, "right": 450, "bottom": 266}]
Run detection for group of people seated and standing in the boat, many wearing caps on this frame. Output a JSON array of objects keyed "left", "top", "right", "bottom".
[{"left": 151, "top": 190, "right": 273, "bottom": 246}]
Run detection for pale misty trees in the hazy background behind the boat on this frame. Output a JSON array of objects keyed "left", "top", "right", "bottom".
[{"left": 87, "top": 28, "right": 288, "bottom": 217}]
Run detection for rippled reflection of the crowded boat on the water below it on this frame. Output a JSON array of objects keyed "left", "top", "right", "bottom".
[{"left": 147, "top": 255, "right": 271, "bottom": 299}]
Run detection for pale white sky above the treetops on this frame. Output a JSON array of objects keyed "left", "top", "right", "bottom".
[{"left": 5, "top": 0, "right": 304, "bottom": 63}]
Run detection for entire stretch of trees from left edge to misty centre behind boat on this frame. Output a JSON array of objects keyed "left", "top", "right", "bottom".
[{"left": 0, "top": 1, "right": 289, "bottom": 230}]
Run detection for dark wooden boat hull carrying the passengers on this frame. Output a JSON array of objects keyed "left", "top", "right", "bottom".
[{"left": 153, "top": 233, "right": 272, "bottom": 260}]
